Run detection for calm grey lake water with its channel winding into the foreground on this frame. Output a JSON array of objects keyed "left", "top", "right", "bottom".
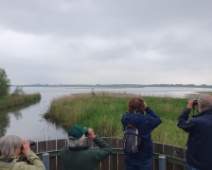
[{"left": 2, "top": 87, "right": 212, "bottom": 141}]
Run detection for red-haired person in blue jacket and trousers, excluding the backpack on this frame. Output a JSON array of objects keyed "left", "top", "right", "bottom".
[{"left": 121, "top": 97, "right": 162, "bottom": 170}]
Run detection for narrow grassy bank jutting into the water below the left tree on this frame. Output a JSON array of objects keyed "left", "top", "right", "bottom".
[{"left": 0, "top": 93, "right": 41, "bottom": 111}]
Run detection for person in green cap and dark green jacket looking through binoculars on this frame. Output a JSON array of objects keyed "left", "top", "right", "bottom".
[{"left": 60, "top": 125, "right": 112, "bottom": 170}]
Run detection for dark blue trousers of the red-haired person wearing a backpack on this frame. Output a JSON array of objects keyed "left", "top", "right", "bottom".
[{"left": 124, "top": 156, "right": 152, "bottom": 170}]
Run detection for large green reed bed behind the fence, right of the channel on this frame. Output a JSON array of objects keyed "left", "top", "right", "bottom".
[{"left": 44, "top": 92, "right": 194, "bottom": 147}]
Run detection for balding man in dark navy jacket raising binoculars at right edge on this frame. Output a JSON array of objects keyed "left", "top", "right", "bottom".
[{"left": 177, "top": 94, "right": 212, "bottom": 170}]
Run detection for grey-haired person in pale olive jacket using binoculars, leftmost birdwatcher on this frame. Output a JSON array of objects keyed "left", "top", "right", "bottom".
[{"left": 0, "top": 135, "right": 45, "bottom": 170}]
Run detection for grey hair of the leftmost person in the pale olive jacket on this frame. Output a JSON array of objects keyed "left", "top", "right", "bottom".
[{"left": 0, "top": 135, "right": 22, "bottom": 158}]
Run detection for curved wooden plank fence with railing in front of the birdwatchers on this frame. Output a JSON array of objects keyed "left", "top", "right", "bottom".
[{"left": 32, "top": 137, "right": 187, "bottom": 170}]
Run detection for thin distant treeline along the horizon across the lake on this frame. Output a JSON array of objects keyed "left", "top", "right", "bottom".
[{"left": 11, "top": 84, "right": 212, "bottom": 88}]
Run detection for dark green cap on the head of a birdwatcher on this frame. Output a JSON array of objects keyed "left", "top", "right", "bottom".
[{"left": 68, "top": 125, "right": 88, "bottom": 139}]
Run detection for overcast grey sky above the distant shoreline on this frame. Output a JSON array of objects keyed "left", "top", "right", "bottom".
[{"left": 0, "top": 0, "right": 212, "bottom": 85}]
